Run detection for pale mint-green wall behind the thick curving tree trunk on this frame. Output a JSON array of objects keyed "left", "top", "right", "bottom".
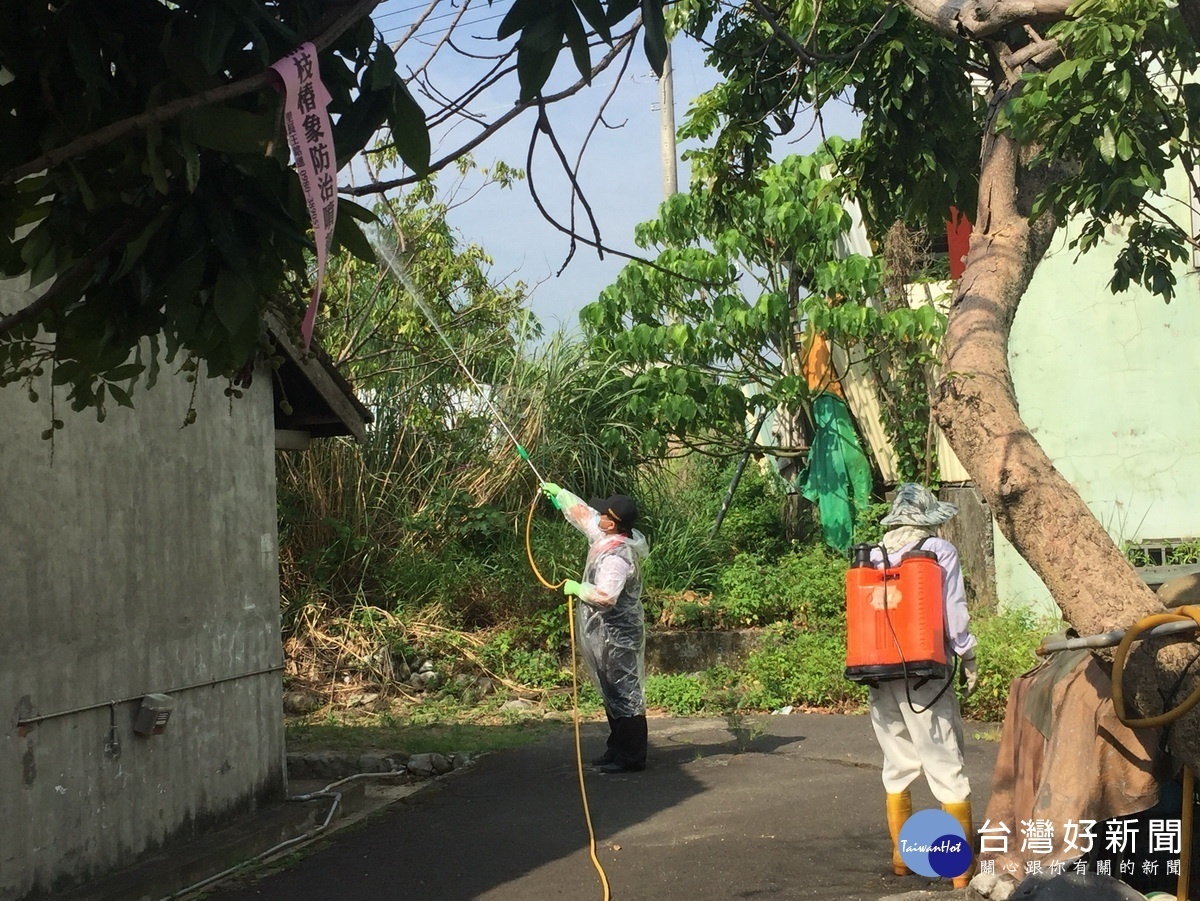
[{"left": 995, "top": 165, "right": 1200, "bottom": 615}]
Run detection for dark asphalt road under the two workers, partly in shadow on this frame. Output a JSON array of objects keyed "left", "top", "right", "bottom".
[{"left": 205, "top": 714, "right": 996, "bottom": 901}]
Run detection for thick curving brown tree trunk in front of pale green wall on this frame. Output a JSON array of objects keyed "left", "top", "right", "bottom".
[{"left": 932, "top": 88, "right": 1200, "bottom": 765}]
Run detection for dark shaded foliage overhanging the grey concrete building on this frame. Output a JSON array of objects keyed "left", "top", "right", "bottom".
[{"left": 0, "top": 0, "right": 430, "bottom": 415}]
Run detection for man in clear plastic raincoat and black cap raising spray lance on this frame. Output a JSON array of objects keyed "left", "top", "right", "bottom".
[{"left": 541, "top": 482, "right": 648, "bottom": 773}]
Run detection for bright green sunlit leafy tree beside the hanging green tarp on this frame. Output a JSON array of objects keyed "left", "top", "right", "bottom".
[{"left": 581, "top": 140, "right": 944, "bottom": 461}]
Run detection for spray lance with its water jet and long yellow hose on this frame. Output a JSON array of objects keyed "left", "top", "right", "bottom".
[{"left": 371, "top": 228, "right": 612, "bottom": 901}]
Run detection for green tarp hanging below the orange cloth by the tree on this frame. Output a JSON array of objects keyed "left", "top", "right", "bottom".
[{"left": 799, "top": 392, "right": 871, "bottom": 551}]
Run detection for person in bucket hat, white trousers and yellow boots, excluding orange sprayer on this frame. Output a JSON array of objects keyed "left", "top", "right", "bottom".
[{"left": 870, "top": 482, "right": 979, "bottom": 888}]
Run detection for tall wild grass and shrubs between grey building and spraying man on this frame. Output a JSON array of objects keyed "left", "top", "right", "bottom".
[{"left": 278, "top": 263, "right": 636, "bottom": 683}]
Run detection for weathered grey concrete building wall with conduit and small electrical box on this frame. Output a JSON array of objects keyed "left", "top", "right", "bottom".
[{"left": 0, "top": 285, "right": 286, "bottom": 901}]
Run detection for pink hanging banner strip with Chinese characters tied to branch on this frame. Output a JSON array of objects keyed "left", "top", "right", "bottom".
[{"left": 271, "top": 43, "right": 337, "bottom": 349}]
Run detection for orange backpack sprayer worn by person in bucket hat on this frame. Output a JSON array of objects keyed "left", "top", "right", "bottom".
[{"left": 846, "top": 545, "right": 947, "bottom": 685}]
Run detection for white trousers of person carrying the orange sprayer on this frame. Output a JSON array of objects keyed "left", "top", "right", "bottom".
[{"left": 870, "top": 679, "right": 971, "bottom": 804}]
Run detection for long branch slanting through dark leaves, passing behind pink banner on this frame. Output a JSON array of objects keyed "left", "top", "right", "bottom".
[{"left": 0, "top": 0, "right": 380, "bottom": 185}]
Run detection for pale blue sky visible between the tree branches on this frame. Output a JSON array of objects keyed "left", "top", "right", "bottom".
[{"left": 374, "top": 0, "right": 858, "bottom": 331}]
